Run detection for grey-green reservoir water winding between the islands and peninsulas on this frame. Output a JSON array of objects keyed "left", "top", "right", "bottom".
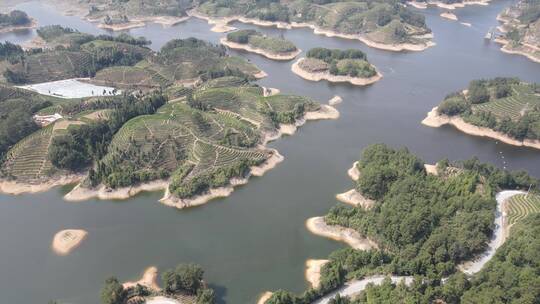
[{"left": 0, "top": 1, "right": 540, "bottom": 304}]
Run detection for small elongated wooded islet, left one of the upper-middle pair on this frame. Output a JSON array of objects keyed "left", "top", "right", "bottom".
[{"left": 221, "top": 30, "right": 301, "bottom": 60}]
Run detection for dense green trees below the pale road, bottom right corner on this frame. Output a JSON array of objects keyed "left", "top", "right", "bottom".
[{"left": 318, "top": 214, "right": 540, "bottom": 304}]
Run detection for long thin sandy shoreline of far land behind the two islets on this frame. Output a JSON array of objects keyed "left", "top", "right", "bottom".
[{"left": 188, "top": 10, "right": 435, "bottom": 52}]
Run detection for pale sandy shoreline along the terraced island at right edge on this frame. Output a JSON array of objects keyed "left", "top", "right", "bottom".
[{"left": 422, "top": 107, "right": 540, "bottom": 149}]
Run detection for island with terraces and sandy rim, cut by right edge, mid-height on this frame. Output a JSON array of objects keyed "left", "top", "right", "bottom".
[{"left": 422, "top": 78, "right": 540, "bottom": 149}]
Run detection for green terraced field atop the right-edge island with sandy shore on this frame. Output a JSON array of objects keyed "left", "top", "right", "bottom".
[{"left": 473, "top": 84, "right": 540, "bottom": 120}]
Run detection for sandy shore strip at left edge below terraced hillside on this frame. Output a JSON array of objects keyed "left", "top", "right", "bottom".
[{"left": 0, "top": 174, "right": 84, "bottom": 195}]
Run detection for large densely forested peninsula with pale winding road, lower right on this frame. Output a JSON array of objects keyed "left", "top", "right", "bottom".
[{"left": 264, "top": 144, "right": 540, "bottom": 304}]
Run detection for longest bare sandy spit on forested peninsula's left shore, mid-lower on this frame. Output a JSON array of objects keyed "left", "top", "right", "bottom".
[{"left": 306, "top": 216, "right": 378, "bottom": 250}]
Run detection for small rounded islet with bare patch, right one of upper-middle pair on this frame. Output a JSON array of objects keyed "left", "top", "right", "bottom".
[{"left": 291, "top": 48, "right": 382, "bottom": 86}]
